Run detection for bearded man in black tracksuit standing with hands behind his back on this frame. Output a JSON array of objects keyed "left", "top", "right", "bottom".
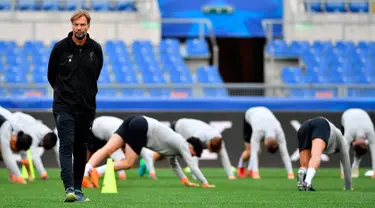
[{"left": 48, "top": 10, "right": 103, "bottom": 202}]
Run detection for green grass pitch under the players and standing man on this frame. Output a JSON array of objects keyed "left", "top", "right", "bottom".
[{"left": 0, "top": 168, "right": 375, "bottom": 208}]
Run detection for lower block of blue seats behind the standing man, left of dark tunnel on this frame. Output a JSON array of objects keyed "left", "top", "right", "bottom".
[{"left": 0, "top": 39, "right": 227, "bottom": 97}]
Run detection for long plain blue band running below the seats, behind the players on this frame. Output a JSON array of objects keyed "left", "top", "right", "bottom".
[{"left": 0, "top": 97, "right": 375, "bottom": 111}]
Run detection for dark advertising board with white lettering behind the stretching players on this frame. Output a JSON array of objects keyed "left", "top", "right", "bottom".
[{"left": 4, "top": 111, "right": 375, "bottom": 169}]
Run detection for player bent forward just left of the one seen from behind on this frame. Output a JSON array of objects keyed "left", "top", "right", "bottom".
[{"left": 238, "top": 107, "right": 294, "bottom": 179}]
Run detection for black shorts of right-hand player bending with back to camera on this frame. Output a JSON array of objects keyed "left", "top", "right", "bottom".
[{"left": 297, "top": 117, "right": 331, "bottom": 152}]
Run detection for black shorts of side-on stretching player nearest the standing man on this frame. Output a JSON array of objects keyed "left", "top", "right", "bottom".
[{"left": 115, "top": 115, "right": 148, "bottom": 155}]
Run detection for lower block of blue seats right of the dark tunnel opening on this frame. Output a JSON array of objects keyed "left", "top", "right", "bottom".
[{"left": 266, "top": 40, "right": 375, "bottom": 97}]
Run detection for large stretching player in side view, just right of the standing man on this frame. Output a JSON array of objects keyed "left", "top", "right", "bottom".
[{"left": 86, "top": 115, "right": 214, "bottom": 188}]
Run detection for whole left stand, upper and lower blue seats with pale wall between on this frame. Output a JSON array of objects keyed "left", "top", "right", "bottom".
[{"left": 0, "top": 0, "right": 228, "bottom": 98}]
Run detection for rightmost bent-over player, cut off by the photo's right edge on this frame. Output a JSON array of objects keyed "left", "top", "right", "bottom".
[{"left": 341, "top": 108, "right": 375, "bottom": 178}]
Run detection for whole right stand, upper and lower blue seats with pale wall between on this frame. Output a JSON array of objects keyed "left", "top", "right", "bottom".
[{"left": 265, "top": 0, "right": 375, "bottom": 98}]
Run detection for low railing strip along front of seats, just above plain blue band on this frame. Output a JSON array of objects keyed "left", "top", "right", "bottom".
[{"left": 0, "top": 83, "right": 375, "bottom": 100}]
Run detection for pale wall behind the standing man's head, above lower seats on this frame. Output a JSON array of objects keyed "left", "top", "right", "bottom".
[{"left": 0, "top": 11, "right": 161, "bottom": 44}]
